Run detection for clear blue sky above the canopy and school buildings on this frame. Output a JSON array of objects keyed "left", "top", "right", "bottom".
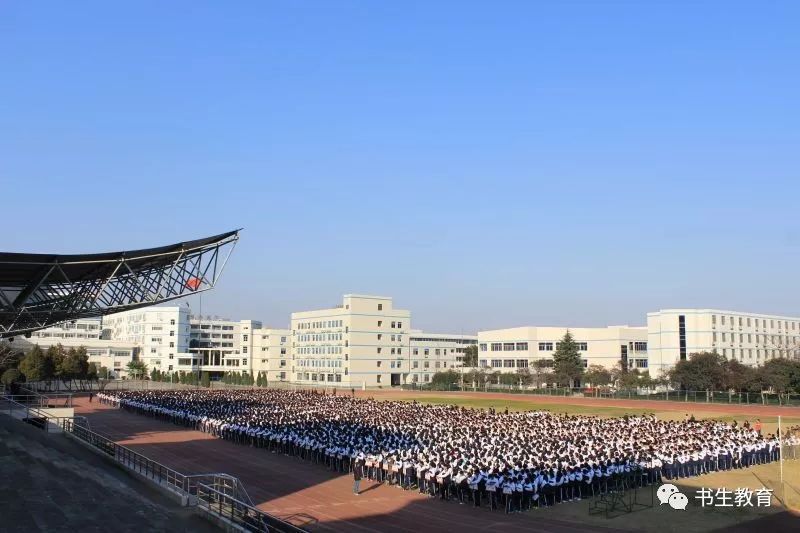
[{"left": 0, "top": 0, "right": 800, "bottom": 333}]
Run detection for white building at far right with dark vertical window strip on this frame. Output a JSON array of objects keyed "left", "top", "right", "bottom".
[{"left": 647, "top": 309, "right": 800, "bottom": 375}]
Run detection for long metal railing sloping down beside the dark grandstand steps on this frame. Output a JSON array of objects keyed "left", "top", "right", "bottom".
[{"left": 62, "top": 419, "right": 305, "bottom": 533}]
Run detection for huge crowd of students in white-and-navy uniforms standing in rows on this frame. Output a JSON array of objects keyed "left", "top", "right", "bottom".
[{"left": 97, "top": 389, "right": 800, "bottom": 512}]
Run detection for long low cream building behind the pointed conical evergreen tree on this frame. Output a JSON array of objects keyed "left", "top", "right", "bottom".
[{"left": 478, "top": 326, "right": 648, "bottom": 378}]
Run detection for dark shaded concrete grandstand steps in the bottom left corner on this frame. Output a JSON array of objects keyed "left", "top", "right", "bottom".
[{"left": 0, "top": 416, "right": 218, "bottom": 533}]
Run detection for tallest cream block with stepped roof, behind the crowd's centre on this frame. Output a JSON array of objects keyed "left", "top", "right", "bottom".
[{"left": 291, "top": 294, "right": 411, "bottom": 387}]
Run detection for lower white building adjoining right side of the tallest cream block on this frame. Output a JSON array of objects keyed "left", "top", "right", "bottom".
[{"left": 405, "top": 330, "right": 478, "bottom": 383}]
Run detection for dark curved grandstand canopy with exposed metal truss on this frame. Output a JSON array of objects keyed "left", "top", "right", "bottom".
[{"left": 0, "top": 230, "right": 239, "bottom": 338}]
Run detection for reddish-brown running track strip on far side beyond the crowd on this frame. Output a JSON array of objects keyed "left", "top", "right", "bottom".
[{"left": 356, "top": 390, "right": 800, "bottom": 418}]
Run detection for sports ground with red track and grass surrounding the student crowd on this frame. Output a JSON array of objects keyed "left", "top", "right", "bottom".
[{"left": 76, "top": 391, "right": 800, "bottom": 532}]
